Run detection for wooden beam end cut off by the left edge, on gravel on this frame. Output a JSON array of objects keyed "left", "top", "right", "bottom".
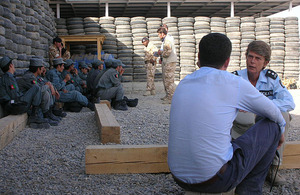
[{"left": 0, "top": 113, "right": 28, "bottom": 150}]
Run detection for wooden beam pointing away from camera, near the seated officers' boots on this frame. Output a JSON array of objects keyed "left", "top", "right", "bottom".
[{"left": 95, "top": 104, "right": 120, "bottom": 144}]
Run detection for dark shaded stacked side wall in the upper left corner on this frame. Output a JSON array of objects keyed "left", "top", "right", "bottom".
[{"left": 0, "top": 0, "right": 56, "bottom": 74}]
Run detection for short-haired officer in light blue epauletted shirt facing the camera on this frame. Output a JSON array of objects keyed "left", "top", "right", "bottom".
[{"left": 232, "top": 41, "right": 295, "bottom": 185}]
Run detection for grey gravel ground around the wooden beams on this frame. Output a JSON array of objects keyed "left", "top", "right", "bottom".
[{"left": 0, "top": 87, "right": 300, "bottom": 195}]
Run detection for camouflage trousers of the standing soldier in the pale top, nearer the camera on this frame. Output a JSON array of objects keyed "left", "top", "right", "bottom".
[{"left": 162, "top": 62, "right": 176, "bottom": 100}]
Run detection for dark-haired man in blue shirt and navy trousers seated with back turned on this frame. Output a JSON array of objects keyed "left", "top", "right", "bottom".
[{"left": 168, "top": 33, "right": 285, "bottom": 195}]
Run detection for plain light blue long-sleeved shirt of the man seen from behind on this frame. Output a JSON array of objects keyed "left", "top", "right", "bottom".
[{"left": 168, "top": 67, "right": 285, "bottom": 183}]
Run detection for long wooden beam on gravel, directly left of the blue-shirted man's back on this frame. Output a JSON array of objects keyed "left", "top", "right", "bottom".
[{"left": 85, "top": 145, "right": 170, "bottom": 174}]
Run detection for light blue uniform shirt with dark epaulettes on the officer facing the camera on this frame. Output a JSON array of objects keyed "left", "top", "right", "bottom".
[{"left": 236, "top": 69, "right": 295, "bottom": 112}]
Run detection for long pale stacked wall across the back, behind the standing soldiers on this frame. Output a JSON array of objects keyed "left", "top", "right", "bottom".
[{"left": 56, "top": 16, "right": 299, "bottom": 81}]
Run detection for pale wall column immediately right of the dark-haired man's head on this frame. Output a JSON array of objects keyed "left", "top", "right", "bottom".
[{"left": 225, "top": 17, "right": 241, "bottom": 72}]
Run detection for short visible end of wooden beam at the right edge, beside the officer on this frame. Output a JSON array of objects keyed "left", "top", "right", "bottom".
[{"left": 280, "top": 141, "right": 300, "bottom": 169}]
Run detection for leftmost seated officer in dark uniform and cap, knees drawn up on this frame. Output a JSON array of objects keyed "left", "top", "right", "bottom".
[{"left": 0, "top": 56, "right": 50, "bottom": 128}]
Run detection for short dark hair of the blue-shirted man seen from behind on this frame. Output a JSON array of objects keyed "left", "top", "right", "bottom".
[{"left": 198, "top": 33, "right": 232, "bottom": 69}]
